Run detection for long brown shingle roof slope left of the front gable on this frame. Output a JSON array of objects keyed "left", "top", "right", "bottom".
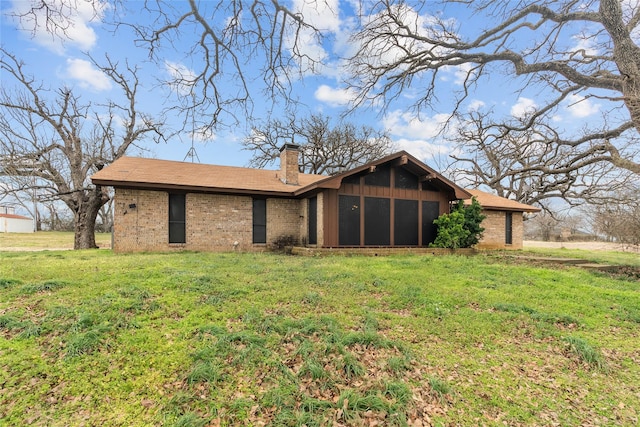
[{"left": 91, "top": 157, "right": 326, "bottom": 194}]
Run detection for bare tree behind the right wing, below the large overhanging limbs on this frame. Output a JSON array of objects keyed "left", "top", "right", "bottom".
[{"left": 450, "top": 111, "right": 637, "bottom": 215}]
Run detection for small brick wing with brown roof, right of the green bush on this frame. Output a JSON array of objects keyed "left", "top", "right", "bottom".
[{"left": 465, "top": 190, "right": 540, "bottom": 249}]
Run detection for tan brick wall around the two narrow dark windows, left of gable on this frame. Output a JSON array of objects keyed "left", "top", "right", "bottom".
[{"left": 113, "top": 188, "right": 307, "bottom": 252}]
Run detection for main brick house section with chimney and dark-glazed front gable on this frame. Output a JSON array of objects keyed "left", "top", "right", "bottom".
[{"left": 91, "top": 144, "right": 536, "bottom": 252}]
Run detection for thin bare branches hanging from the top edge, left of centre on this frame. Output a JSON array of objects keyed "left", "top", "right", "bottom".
[{"left": 129, "top": 0, "right": 322, "bottom": 130}]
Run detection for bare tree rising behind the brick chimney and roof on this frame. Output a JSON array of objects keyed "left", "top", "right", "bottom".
[{"left": 243, "top": 114, "right": 392, "bottom": 175}]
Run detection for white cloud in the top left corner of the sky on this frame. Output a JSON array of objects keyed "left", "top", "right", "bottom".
[{"left": 11, "top": 0, "right": 108, "bottom": 55}]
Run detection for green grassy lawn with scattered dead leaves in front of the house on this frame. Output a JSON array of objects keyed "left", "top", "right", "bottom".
[{"left": 0, "top": 250, "right": 640, "bottom": 426}]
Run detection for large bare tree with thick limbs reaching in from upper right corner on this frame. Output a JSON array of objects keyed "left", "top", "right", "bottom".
[{"left": 349, "top": 0, "right": 640, "bottom": 174}]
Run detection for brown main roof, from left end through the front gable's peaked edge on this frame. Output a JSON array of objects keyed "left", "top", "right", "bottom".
[{"left": 91, "top": 151, "right": 471, "bottom": 199}]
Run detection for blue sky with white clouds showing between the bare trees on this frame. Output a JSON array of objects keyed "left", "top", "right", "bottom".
[{"left": 0, "top": 0, "right": 601, "bottom": 169}]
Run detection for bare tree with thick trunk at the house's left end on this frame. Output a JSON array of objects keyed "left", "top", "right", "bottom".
[{"left": 0, "top": 50, "right": 163, "bottom": 249}]
